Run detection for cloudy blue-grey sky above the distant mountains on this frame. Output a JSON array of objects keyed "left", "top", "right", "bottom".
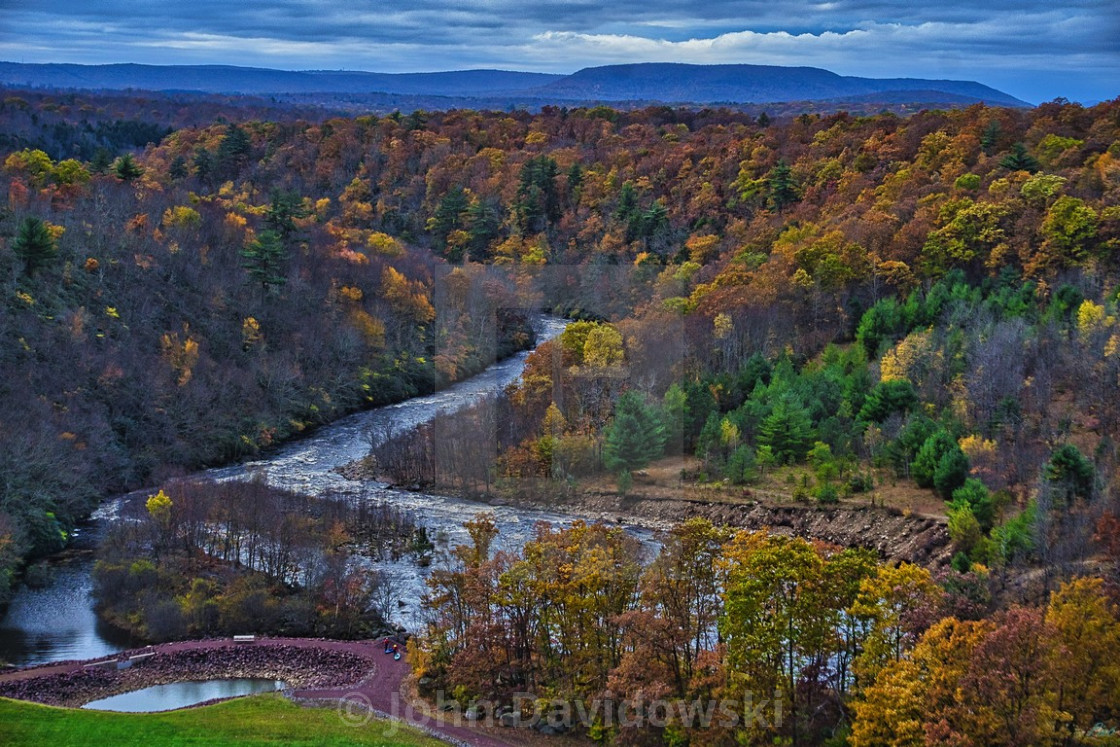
[{"left": 0, "top": 0, "right": 1120, "bottom": 103}]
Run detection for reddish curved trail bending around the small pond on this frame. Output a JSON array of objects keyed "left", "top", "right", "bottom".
[{"left": 0, "top": 637, "right": 519, "bottom": 747}]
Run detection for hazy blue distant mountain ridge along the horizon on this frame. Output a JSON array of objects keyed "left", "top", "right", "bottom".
[{"left": 0, "top": 62, "right": 1029, "bottom": 106}]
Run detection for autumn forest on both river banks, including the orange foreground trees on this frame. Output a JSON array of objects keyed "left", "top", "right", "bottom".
[{"left": 0, "top": 89, "right": 1120, "bottom": 745}]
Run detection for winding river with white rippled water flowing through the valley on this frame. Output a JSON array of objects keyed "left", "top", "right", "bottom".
[{"left": 0, "top": 317, "right": 655, "bottom": 665}]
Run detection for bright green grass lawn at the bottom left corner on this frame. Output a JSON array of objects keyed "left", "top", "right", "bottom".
[{"left": 0, "top": 694, "right": 444, "bottom": 747}]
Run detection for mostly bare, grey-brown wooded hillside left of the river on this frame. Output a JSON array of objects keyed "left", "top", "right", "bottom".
[{"left": 0, "top": 97, "right": 532, "bottom": 590}]
